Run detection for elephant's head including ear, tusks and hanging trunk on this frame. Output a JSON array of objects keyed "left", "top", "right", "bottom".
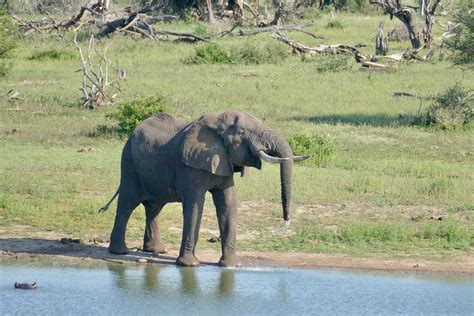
[{"left": 182, "top": 112, "right": 308, "bottom": 221}]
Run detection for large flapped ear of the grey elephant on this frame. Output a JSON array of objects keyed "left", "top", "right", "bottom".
[{"left": 181, "top": 119, "right": 234, "bottom": 176}]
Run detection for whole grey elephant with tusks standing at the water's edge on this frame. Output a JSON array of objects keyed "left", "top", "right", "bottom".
[{"left": 101, "top": 112, "right": 307, "bottom": 266}]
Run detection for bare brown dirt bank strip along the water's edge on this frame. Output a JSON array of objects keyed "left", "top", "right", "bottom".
[{"left": 0, "top": 236, "right": 474, "bottom": 274}]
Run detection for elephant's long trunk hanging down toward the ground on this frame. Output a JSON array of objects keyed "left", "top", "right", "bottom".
[{"left": 270, "top": 134, "right": 293, "bottom": 221}]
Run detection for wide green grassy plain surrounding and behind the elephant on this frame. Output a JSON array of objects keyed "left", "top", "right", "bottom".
[{"left": 0, "top": 9, "right": 474, "bottom": 260}]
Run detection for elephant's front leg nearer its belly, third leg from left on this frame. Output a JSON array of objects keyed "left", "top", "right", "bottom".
[{"left": 176, "top": 192, "right": 205, "bottom": 267}]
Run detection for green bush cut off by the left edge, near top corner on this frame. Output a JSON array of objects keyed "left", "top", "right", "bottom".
[{"left": 0, "top": 9, "right": 17, "bottom": 77}]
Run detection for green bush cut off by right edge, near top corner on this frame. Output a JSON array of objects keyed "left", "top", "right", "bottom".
[{"left": 445, "top": 9, "right": 474, "bottom": 68}]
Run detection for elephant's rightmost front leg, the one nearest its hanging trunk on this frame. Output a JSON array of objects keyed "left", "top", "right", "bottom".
[{"left": 211, "top": 181, "right": 241, "bottom": 267}]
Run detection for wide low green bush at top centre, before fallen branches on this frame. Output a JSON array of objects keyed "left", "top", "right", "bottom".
[{"left": 184, "top": 42, "right": 288, "bottom": 65}]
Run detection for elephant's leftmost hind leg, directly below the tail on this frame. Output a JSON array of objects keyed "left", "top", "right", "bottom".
[{"left": 109, "top": 189, "right": 141, "bottom": 255}]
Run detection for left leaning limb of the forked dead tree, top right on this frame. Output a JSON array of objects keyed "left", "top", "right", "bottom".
[{"left": 370, "top": 0, "right": 421, "bottom": 49}]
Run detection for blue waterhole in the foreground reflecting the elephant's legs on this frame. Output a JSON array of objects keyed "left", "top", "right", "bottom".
[{"left": 0, "top": 263, "right": 474, "bottom": 315}]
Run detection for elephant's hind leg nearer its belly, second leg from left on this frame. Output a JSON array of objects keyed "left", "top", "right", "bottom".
[{"left": 142, "top": 200, "right": 166, "bottom": 253}]
